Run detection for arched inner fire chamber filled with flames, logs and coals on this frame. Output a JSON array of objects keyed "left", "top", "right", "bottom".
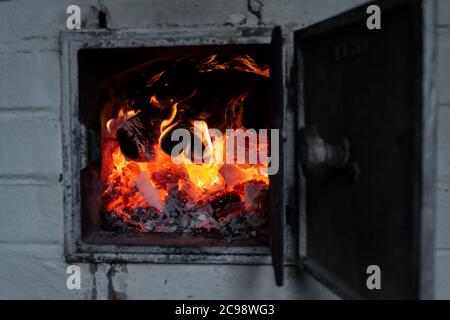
[{"left": 100, "top": 55, "right": 270, "bottom": 239}]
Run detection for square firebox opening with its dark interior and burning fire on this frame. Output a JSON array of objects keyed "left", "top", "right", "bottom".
[{"left": 78, "top": 45, "right": 273, "bottom": 246}]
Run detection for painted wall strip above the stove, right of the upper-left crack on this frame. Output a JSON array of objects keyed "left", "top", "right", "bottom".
[{"left": 102, "top": 0, "right": 367, "bottom": 29}]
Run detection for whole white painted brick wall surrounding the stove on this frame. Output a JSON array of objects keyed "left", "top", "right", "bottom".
[{"left": 0, "top": 0, "right": 450, "bottom": 299}]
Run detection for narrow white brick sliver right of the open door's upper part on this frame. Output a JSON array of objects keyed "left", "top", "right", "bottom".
[{"left": 438, "top": 28, "right": 450, "bottom": 104}]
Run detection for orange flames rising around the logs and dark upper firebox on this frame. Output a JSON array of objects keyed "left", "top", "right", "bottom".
[{"left": 102, "top": 55, "right": 269, "bottom": 218}]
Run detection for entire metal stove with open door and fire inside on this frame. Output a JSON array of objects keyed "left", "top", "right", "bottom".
[{"left": 61, "top": 0, "right": 435, "bottom": 298}]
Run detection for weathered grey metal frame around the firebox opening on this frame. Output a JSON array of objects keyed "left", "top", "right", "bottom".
[{"left": 61, "top": 27, "right": 293, "bottom": 264}]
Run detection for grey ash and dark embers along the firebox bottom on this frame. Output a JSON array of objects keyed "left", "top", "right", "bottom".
[{"left": 103, "top": 183, "right": 268, "bottom": 240}]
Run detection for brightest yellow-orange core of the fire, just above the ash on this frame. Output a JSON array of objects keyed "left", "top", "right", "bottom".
[{"left": 107, "top": 111, "right": 269, "bottom": 210}]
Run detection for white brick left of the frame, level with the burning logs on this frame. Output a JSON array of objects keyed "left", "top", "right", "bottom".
[{"left": 0, "top": 117, "right": 62, "bottom": 176}]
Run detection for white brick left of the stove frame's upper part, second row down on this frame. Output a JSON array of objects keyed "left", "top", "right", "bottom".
[{"left": 0, "top": 52, "right": 61, "bottom": 110}]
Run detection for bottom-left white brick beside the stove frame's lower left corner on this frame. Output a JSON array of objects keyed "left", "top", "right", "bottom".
[{"left": 0, "top": 243, "right": 93, "bottom": 299}]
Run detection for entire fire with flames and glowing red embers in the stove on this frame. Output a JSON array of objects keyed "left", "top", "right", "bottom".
[{"left": 102, "top": 55, "right": 269, "bottom": 235}]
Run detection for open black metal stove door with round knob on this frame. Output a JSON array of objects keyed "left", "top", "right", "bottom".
[{"left": 295, "top": 0, "right": 435, "bottom": 299}]
